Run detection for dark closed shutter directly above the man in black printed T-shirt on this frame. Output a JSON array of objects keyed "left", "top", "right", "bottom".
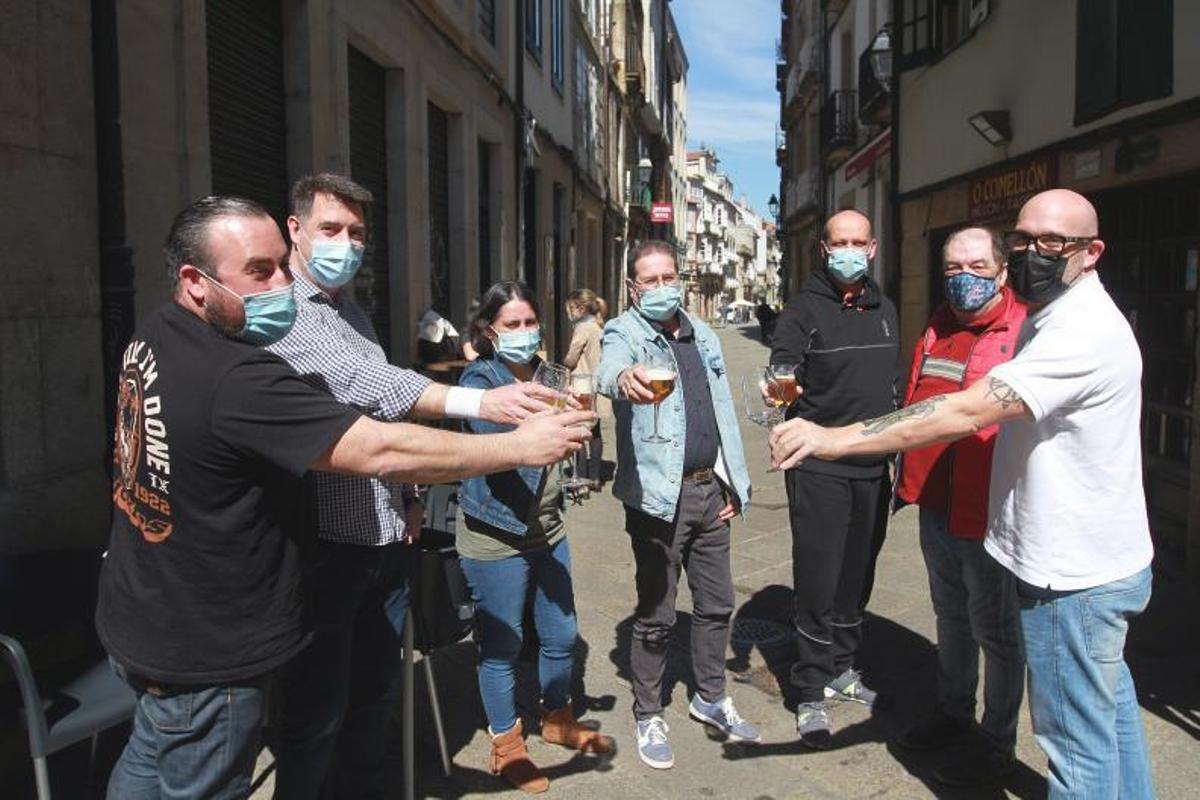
[{"left": 205, "top": 0, "right": 288, "bottom": 225}]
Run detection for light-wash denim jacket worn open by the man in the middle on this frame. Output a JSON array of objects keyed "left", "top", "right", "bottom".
[{"left": 598, "top": 309, "right": 750, "bottom": 521}]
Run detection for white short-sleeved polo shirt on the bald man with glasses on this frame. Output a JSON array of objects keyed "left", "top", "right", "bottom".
[{"left": 984, "top": 273, "right": 1153, "bottom": 590}]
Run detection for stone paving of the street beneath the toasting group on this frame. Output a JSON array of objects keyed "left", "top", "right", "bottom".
[{"left": 254, "top": 325, "right": 1200, "bottom": 800}]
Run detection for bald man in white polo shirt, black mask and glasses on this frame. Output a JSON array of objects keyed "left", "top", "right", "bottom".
[{"left": 770, "top": 190, "right": 1154, "bottom": 800}]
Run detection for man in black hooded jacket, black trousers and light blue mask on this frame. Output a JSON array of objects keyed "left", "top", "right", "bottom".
[{"left": 770, "top": 211, "right": 899, "bottom": 750}]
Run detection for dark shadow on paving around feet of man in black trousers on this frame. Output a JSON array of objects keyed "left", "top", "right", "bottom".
[{"left": 724, "top": 594, "right": 1046, "bottom": 800}]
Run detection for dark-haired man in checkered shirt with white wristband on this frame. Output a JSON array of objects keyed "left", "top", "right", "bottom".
[{"left": 269, "top": 173, "right": 552, "bottom": 800}]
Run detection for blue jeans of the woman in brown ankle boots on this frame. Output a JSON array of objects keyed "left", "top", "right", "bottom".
[{"left": 460, "top": 536, "right": 576, "bottom": 733}]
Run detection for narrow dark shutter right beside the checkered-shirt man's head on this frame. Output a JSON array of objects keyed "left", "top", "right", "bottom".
[{"left": 347, "top": 47, "right": 391, "bottom": 356}]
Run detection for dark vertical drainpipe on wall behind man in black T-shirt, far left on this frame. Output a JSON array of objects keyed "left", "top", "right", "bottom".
[{"left": 91, "top": 0, "right": 134, "bottom": 453}]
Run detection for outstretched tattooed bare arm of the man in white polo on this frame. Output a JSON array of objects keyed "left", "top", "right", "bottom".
[{"left": 770, "top": 375, "right": 1032, "bottom": 469}]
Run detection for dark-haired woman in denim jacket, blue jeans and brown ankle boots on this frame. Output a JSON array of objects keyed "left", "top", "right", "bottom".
[{"left": 457, "top": 281, "right": 613, "bottom": 792}]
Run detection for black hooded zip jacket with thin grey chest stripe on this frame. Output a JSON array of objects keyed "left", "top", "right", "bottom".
[{"left": 770, "top": 269, "right": 900, "bottom": 477}]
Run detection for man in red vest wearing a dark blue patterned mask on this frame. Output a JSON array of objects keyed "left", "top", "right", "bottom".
[{"left": 895, "top": 228, "right": 1025, "bottom": 786}]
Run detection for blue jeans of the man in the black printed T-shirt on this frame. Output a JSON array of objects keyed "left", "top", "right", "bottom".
[{"left": 108, "top": 663, "right": 269, "bottom": 800}]
